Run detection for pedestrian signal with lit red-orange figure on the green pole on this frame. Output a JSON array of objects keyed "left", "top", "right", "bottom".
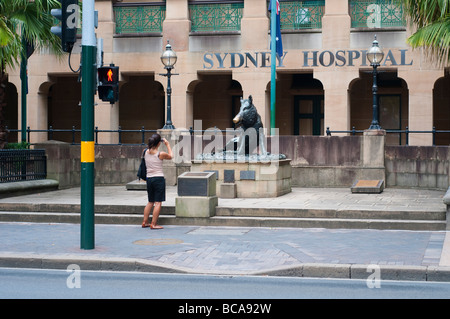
[{"left": 97, "top": 64, "right": 119, "bottom": 104}]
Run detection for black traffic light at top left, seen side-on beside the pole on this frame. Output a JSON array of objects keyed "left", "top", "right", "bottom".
[{"left": 50, "top": 0, "right": 79, "bottom": 52}]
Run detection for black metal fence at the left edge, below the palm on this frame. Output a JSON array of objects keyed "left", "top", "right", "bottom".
[{"left": 0, "top": 150, "right": 47, "bottom": 183}]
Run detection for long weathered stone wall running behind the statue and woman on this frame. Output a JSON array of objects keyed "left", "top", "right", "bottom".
[{"left": 35, "top": 135, "right": 450, "bottom": 189}]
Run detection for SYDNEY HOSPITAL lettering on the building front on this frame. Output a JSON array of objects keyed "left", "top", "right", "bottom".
[{"left": 203, "top": 49, "right": 413, "bottom": 70}]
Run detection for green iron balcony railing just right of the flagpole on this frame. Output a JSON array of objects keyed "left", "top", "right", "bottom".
[{"left": 280, "top": 0, "right": 325, "bottom": 31}]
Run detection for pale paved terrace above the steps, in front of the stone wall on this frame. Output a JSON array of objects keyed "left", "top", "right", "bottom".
[{"left": 0, "top": 186, "right": 446, "bottom": 212}]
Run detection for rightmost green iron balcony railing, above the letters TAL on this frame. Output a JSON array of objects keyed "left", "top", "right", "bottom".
[{"left": 349, "top": 0, "right": 406, "bottom": 29}]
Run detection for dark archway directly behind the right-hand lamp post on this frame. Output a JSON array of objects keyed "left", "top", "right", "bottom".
[{"left": 349, "top": 70, "right": 409, "bottom": 145}]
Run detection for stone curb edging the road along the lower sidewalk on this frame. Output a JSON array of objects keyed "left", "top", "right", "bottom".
[{"left": 0, "top": 255, "right": 450, "bottom": 282}]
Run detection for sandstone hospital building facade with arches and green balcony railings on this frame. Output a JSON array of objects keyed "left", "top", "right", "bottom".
[{"left": 6, "top": 0, "right": 450, "bottom": 145}]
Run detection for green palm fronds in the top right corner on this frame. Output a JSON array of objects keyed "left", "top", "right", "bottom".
[{"left": 401, "top": 0, "right": 450, "bottom": 65}]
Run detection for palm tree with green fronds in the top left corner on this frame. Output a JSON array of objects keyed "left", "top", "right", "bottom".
[{"left": 0, "top": 0, "right": 62, "bottom": 149}]
